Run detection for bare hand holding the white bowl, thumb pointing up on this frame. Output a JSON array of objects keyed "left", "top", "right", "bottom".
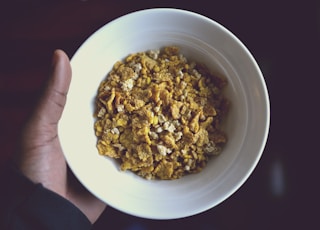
[{"left": 15, "top": 50, "right": 106, "bottom": 223}]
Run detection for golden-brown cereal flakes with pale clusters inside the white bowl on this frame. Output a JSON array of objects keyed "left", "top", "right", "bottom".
[{"left": 94, "top": 46, "right": 229, "bottom": 180}]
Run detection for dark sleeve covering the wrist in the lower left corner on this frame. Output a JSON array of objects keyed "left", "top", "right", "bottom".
[{"left": 0, "top": 163, "right": 91, "bottom": 230}]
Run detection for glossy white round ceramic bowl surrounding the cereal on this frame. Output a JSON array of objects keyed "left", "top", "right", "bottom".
[{"left": 59, "top": 9, "right": 269, "bottom": 219}]
